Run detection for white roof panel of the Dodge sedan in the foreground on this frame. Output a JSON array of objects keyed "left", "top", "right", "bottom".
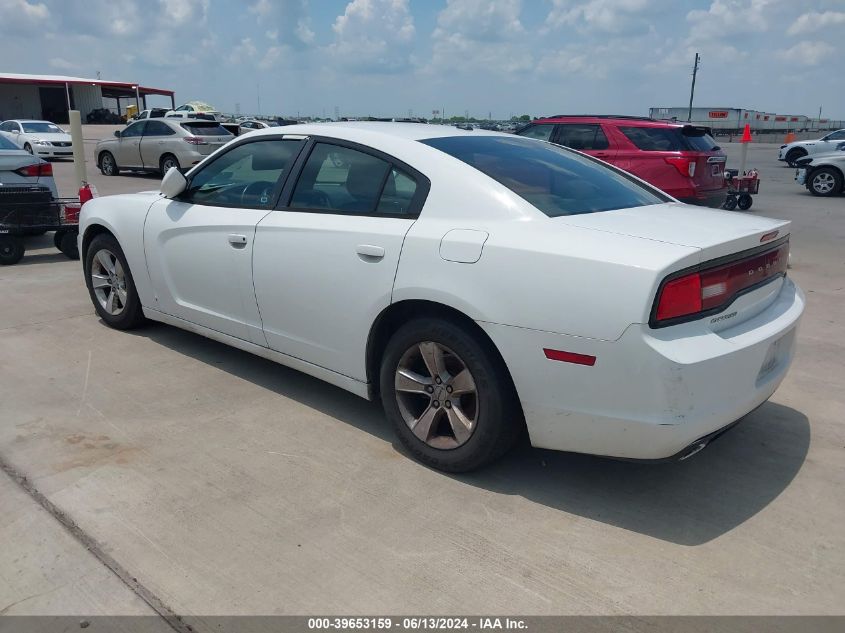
[{"left": 244, "top": 121, "right": 513, "bottom": 141}]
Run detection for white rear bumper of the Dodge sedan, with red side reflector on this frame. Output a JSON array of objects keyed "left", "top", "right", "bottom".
[{"left": 480, "top": 279, "right": 804, "bottom": 460}]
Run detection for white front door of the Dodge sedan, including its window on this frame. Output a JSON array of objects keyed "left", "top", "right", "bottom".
[{"left": 144, "top": 137, "right": 303, "bottom": 346}]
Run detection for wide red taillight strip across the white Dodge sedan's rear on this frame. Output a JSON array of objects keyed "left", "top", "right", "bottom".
[{"left": 650, "top": 238, "right": 789, "bottom": 327}]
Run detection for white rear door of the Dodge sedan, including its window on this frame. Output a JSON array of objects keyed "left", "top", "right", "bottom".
[{"left": 253, "top": 139, "right": 428, "bottom": 381}]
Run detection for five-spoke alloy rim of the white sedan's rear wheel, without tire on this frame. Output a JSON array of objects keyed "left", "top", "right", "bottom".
[{"left": 394, "top": 341, "right": 479, "bottom": 450}]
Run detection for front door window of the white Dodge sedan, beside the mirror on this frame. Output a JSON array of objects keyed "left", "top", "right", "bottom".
[{"left": 180, "top": 139, "right": 302, "bottom": 209}]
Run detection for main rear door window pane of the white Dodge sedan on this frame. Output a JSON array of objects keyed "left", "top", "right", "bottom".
[{"left": 290, "top": 143, "right": 391, "bottom": 214}]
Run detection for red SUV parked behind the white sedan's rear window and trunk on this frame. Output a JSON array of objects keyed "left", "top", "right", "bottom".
[{"left": 517, "top": 116, "right": 727, "bottom": 207}]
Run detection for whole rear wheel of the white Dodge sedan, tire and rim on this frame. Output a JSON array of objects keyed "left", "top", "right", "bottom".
[{"left": 380, "top": 318, "right": 523, "bottom": 472}]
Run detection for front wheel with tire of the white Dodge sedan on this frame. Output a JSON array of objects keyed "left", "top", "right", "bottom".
[{"left": 85, "top": 233, "right": 145, "bottom": 330}]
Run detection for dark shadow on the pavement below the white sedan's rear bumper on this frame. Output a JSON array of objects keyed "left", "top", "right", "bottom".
[{"left": 452, "top": 402, "right": 810, "bottom": 545}]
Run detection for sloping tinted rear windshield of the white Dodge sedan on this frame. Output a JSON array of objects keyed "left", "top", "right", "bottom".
[{"left": 422, "top": 136, "right": 669, "bottom": 217}]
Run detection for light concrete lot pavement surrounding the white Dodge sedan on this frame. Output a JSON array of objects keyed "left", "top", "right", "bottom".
[{"left": 0, "top": 126, "right": 845, "bottom": 616}]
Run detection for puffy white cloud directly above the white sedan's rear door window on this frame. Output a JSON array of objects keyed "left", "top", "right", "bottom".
[{"left": 326, "top": 0, "right": 416, "bottom": 72}]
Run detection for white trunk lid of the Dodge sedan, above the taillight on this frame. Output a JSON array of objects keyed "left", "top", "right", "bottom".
[{"left": 553, "top": 202, "right": 790, "bottom": 262}]
